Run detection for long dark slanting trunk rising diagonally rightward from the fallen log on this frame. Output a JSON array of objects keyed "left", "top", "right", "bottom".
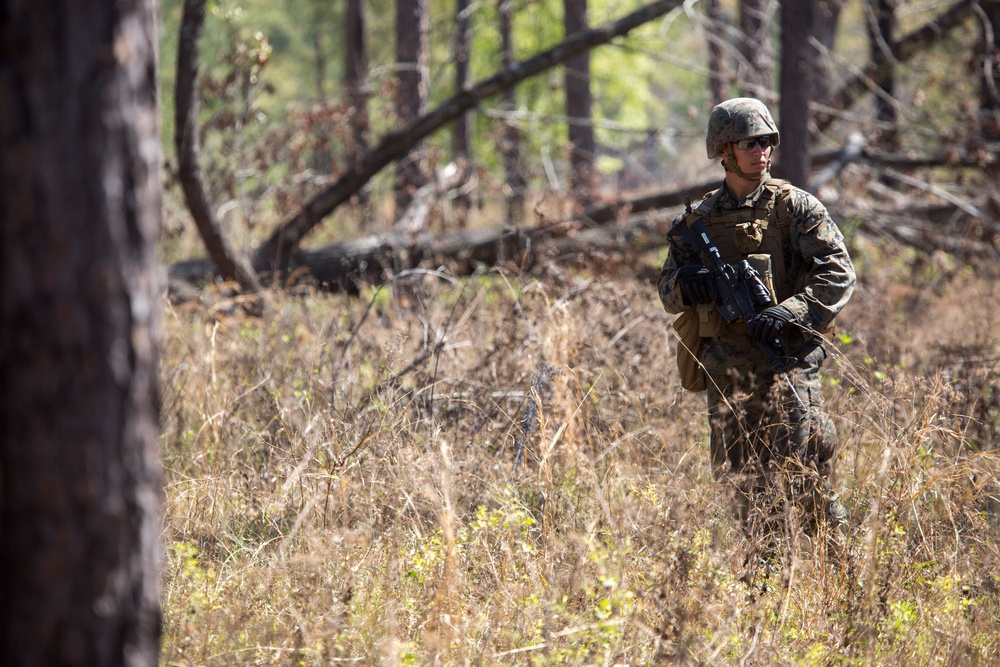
[{"left": 254, "top": 0, "right": 682, "bottom": 271}]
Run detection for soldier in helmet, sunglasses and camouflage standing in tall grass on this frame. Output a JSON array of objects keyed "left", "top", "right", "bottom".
[{"left": 657, "top": 98, "right": 855, "bottom": 536}]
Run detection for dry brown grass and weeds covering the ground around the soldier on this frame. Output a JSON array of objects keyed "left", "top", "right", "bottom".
[{"left": 162, "top": 252, "right": 1000, "bottom": 666}]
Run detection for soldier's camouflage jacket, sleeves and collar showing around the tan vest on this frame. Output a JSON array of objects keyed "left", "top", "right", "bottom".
[{"left": 657, "top": 176, "right": 856, "bottom": 331}]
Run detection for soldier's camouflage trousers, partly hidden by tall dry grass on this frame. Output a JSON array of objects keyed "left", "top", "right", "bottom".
[{"left": 701, "top": 337, "right": 844, "bottom": 535}]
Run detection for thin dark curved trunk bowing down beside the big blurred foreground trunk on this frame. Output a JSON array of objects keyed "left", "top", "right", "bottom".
[{"left": 174, "top": 0, "right": 264, "bottom": 295}]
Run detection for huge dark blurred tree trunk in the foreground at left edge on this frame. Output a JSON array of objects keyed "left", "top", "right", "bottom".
[{"left": 0, "top": 0, "right": 162, "bottom": 667}]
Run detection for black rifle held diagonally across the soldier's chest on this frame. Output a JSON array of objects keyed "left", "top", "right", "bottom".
[{"left": 675, "top": 197, "right": 806, "bottom": 412}]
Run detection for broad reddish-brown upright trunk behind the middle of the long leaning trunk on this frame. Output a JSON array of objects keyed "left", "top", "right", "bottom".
[{"left": 395, "top": 0, "right": 429, "bottom": 214}]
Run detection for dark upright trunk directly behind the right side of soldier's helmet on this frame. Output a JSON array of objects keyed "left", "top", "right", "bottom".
[{"left": 775, "top": 0, "right": 815, "bottom": 189}]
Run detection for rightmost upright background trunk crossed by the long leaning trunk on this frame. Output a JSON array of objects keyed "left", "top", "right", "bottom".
[{"left": 563, "top": 0, "right": 597, "bottom": 208}]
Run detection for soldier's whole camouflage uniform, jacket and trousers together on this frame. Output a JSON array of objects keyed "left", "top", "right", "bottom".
[{"left": 657, "top": 98, "right": 855, "bottom": 536}]
